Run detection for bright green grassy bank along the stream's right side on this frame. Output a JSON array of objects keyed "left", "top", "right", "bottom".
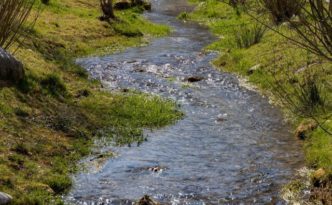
[{"left": 183, "top": 0, "right": 332, "bottom": 204}]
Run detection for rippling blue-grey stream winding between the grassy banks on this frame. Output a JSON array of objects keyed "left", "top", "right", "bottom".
[{"left": 67, "top": 0, "right": 303, "bottom": 205}]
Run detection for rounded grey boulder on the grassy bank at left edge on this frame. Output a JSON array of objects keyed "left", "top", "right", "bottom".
[{"left": 0, "top": 48, "right": 24, "bottom": 85}]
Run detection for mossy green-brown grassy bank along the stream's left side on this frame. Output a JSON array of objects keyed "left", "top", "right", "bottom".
[{"left": 0, "top": 0, "right": 181, "bottom": 205}]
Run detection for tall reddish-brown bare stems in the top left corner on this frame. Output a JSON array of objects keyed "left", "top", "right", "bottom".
[{"left": 0, "top": 0, "right": 35, "bottom": 49}]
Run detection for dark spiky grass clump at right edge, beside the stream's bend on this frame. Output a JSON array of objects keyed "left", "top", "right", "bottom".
[{"left": 271, "top": 67, "right": 331, "bottom": 134}]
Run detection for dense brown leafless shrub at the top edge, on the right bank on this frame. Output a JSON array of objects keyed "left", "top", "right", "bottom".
[{"left": 261, "top": 0, "right": 304, "bottom": 24}]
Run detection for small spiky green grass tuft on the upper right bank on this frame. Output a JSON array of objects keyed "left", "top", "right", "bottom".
[{"left": 234, "top": 24, "right": 266, "bottom": 48}]
